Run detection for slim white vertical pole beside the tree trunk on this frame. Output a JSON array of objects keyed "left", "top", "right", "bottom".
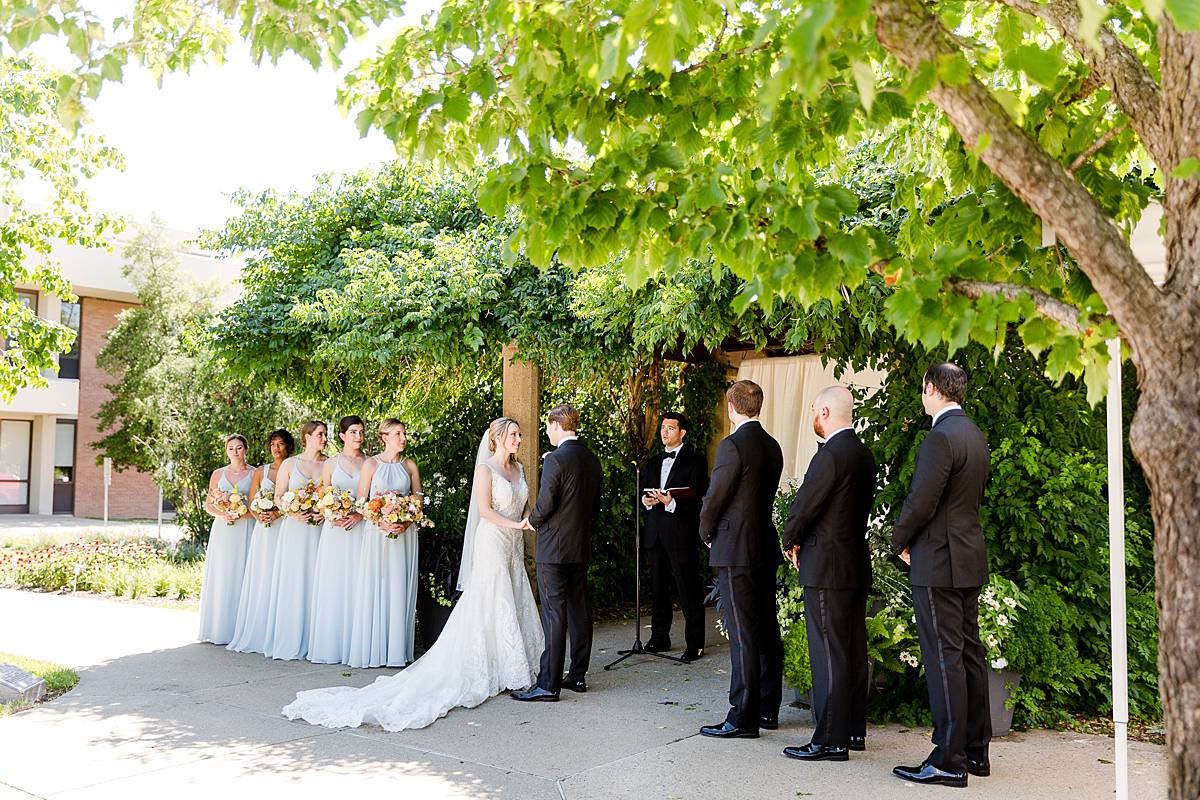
[{"left": 1108, "top": 338, "right": 1129, "bottom": 800}]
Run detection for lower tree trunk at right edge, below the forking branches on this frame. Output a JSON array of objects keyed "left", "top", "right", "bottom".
[{"left": 1129, "top": 352, "right": 1200, "bottom": 800}]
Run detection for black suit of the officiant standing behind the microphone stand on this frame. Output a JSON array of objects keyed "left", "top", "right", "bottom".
[{"left": 637, "top": 445, "right": 708, "bottom": 650}]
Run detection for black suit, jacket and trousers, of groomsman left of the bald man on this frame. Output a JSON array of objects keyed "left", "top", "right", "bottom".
[{"left": 700, "top": 420, "right": 784, "bottom": 730}]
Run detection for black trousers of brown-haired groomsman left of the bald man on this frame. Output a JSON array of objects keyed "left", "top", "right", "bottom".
[{"left": 716, "top": 566, "right": 784, "bottom": 730}]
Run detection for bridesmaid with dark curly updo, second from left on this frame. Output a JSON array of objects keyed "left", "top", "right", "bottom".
[{"left": 229, "top": 428, "right": 296, "bottom": 652}]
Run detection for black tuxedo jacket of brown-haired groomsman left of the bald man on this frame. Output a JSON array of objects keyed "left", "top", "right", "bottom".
[{"left": 700, "top": 420, "right": 784, "bottom": 566}]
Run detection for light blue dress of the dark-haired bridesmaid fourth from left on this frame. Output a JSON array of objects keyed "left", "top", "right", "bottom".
[{"left": 308, "top": 456, "right": 366, "bottom": 664}]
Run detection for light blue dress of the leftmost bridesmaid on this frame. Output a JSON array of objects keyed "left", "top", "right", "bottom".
[{"left": 199, "top": 467, "right": 254, "bottom": 644}]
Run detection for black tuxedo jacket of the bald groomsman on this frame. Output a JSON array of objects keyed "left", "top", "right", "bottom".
[{"left": 784, "top": 431, "right": 875, "bottom": 589}]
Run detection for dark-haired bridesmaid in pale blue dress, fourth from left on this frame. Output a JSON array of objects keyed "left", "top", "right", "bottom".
[{"left": 308, "top": 416, "right": 365, "bottom": 664}]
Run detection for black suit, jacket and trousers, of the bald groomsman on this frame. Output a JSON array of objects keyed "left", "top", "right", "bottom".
[{"left": 784, "top": 431, "right": 875, "bottom": 747}]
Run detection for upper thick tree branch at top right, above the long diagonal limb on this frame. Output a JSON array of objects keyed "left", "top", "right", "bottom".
[{"left": 997, "top": 0, "right": 1172, "bottom": 167}]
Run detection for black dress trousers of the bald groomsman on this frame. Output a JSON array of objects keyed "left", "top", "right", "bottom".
[{"left": 804, "top": 587, "right": 868, "bottom": 747}]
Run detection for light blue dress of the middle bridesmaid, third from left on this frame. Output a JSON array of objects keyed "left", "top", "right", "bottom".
[{"left": 263, "top": 457, "right": 320, "bottom": 661}]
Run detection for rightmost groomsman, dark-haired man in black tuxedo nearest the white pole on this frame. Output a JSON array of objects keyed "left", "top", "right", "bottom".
[{"left": 892, "top": 363, "right": 991, "bottom": 787}]
